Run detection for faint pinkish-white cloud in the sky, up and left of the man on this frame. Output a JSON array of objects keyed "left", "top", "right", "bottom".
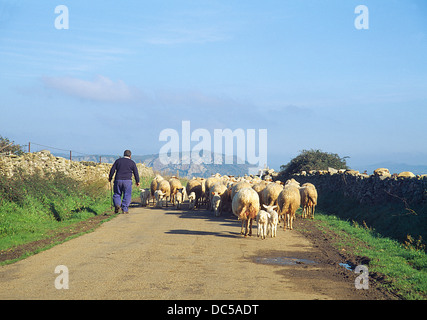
[{"left": 42, "top": 75, "right": 138, "bottom": 102}]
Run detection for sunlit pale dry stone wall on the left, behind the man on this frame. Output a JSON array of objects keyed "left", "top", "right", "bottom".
[{"left": 0, "top": 150, "right": 154, "bottom": 184}]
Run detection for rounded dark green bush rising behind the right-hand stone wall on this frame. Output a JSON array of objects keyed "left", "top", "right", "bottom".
[{"left": 280, "top": 149, "right": 348, "bottom": 177}]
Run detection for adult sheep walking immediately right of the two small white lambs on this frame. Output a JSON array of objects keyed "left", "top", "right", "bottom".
[{"left": 277, "top": 184, "right": 301, "bottom": 230}]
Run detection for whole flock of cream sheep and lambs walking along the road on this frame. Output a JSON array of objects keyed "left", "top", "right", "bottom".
[{"left": 140, "top": 173, "right": 317, "bottom": 239}]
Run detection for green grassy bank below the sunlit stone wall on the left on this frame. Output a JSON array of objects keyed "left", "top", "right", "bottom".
[{"left": 0, "top": 173, "right": 110, "bottom": 250}]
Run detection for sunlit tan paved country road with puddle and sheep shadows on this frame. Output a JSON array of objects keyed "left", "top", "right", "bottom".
[{"left": 0, "top": 207, "right": 378, "bottom": 300}]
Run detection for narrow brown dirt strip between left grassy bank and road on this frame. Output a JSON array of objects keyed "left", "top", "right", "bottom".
[{"left": 0, "top": 212, "right": 112, "bottom": 262}]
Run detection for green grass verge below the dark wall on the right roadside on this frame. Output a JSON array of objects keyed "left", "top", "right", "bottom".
[{"left": 316, "top": 210, "right": 427, "bottom": 300}]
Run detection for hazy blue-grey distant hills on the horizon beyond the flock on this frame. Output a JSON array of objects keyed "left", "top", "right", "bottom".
[{"left": 51, "top": 153, "right": 253, "bottom": 178}]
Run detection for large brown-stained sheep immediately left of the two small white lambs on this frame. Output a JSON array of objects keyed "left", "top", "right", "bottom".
[{"left": 231, "top": 187, "right": 259, "bottom": 237}]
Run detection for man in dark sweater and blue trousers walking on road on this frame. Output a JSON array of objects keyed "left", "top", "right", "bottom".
[{"left": 108, "top": 150, "right": 139, "bottom": 213}]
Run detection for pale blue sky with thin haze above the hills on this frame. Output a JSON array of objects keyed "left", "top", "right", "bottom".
[{"left": 0, "top": 0, "right": 427, "bottom": 170}]
